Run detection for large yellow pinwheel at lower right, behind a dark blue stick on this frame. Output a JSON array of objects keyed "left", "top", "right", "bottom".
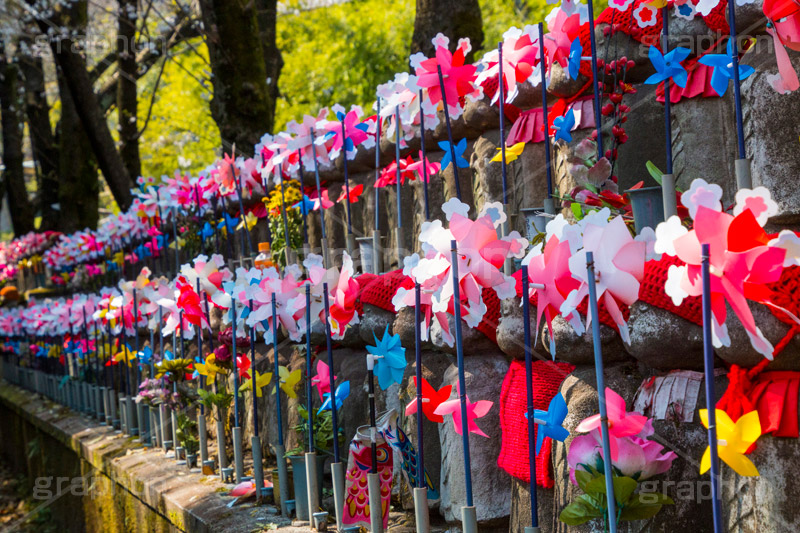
[{"left": 700, "top": 409, "right": 761, "bottom": 476}]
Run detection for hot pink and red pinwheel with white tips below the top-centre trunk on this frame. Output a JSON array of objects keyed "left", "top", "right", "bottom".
[{"left": 411, "top": 33, "right": 483, "bottom": 118}]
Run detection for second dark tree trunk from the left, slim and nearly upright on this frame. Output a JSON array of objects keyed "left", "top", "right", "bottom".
[{"left": 19, "top": 40, "right": 59, "bottom": 231}]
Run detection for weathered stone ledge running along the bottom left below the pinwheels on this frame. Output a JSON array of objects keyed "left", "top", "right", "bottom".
[{"left": 0, "top": 382, "right": 310, "bottom": 533}]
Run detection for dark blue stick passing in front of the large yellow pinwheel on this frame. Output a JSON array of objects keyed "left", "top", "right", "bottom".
[{"left": 701, "top": 243, "right": 724, "bottom": 533}]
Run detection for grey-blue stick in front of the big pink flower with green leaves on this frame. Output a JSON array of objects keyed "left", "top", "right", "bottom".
[{"left": 588, "top": 252, "right": 617, "bottom": 533}]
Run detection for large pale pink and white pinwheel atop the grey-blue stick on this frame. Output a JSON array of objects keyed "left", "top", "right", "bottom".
[{"left": 561, "top": 216, "right": 647, "bottom": 344}]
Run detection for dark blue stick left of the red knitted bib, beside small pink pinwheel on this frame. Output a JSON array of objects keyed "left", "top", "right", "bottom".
[{"left": 446, "top": 240, "right": 478, "bottom": 532}]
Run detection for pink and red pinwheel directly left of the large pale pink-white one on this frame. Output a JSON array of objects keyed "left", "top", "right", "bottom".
[{"left": 522, "top": 235, "right": 583, "bottom": 358}]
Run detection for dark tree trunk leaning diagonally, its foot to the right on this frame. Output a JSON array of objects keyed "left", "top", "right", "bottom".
[{"left": 26, "top": 0, "right": 133, "bottom": 211}]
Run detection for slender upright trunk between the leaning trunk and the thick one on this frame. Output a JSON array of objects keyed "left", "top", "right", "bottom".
[{"left": 117, "top": 0, "right": 142, "bottom": 180}]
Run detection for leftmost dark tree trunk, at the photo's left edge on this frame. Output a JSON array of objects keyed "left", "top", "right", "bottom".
[{"left": 0, "top": 40, "right": 33, "bottom": 237}]
